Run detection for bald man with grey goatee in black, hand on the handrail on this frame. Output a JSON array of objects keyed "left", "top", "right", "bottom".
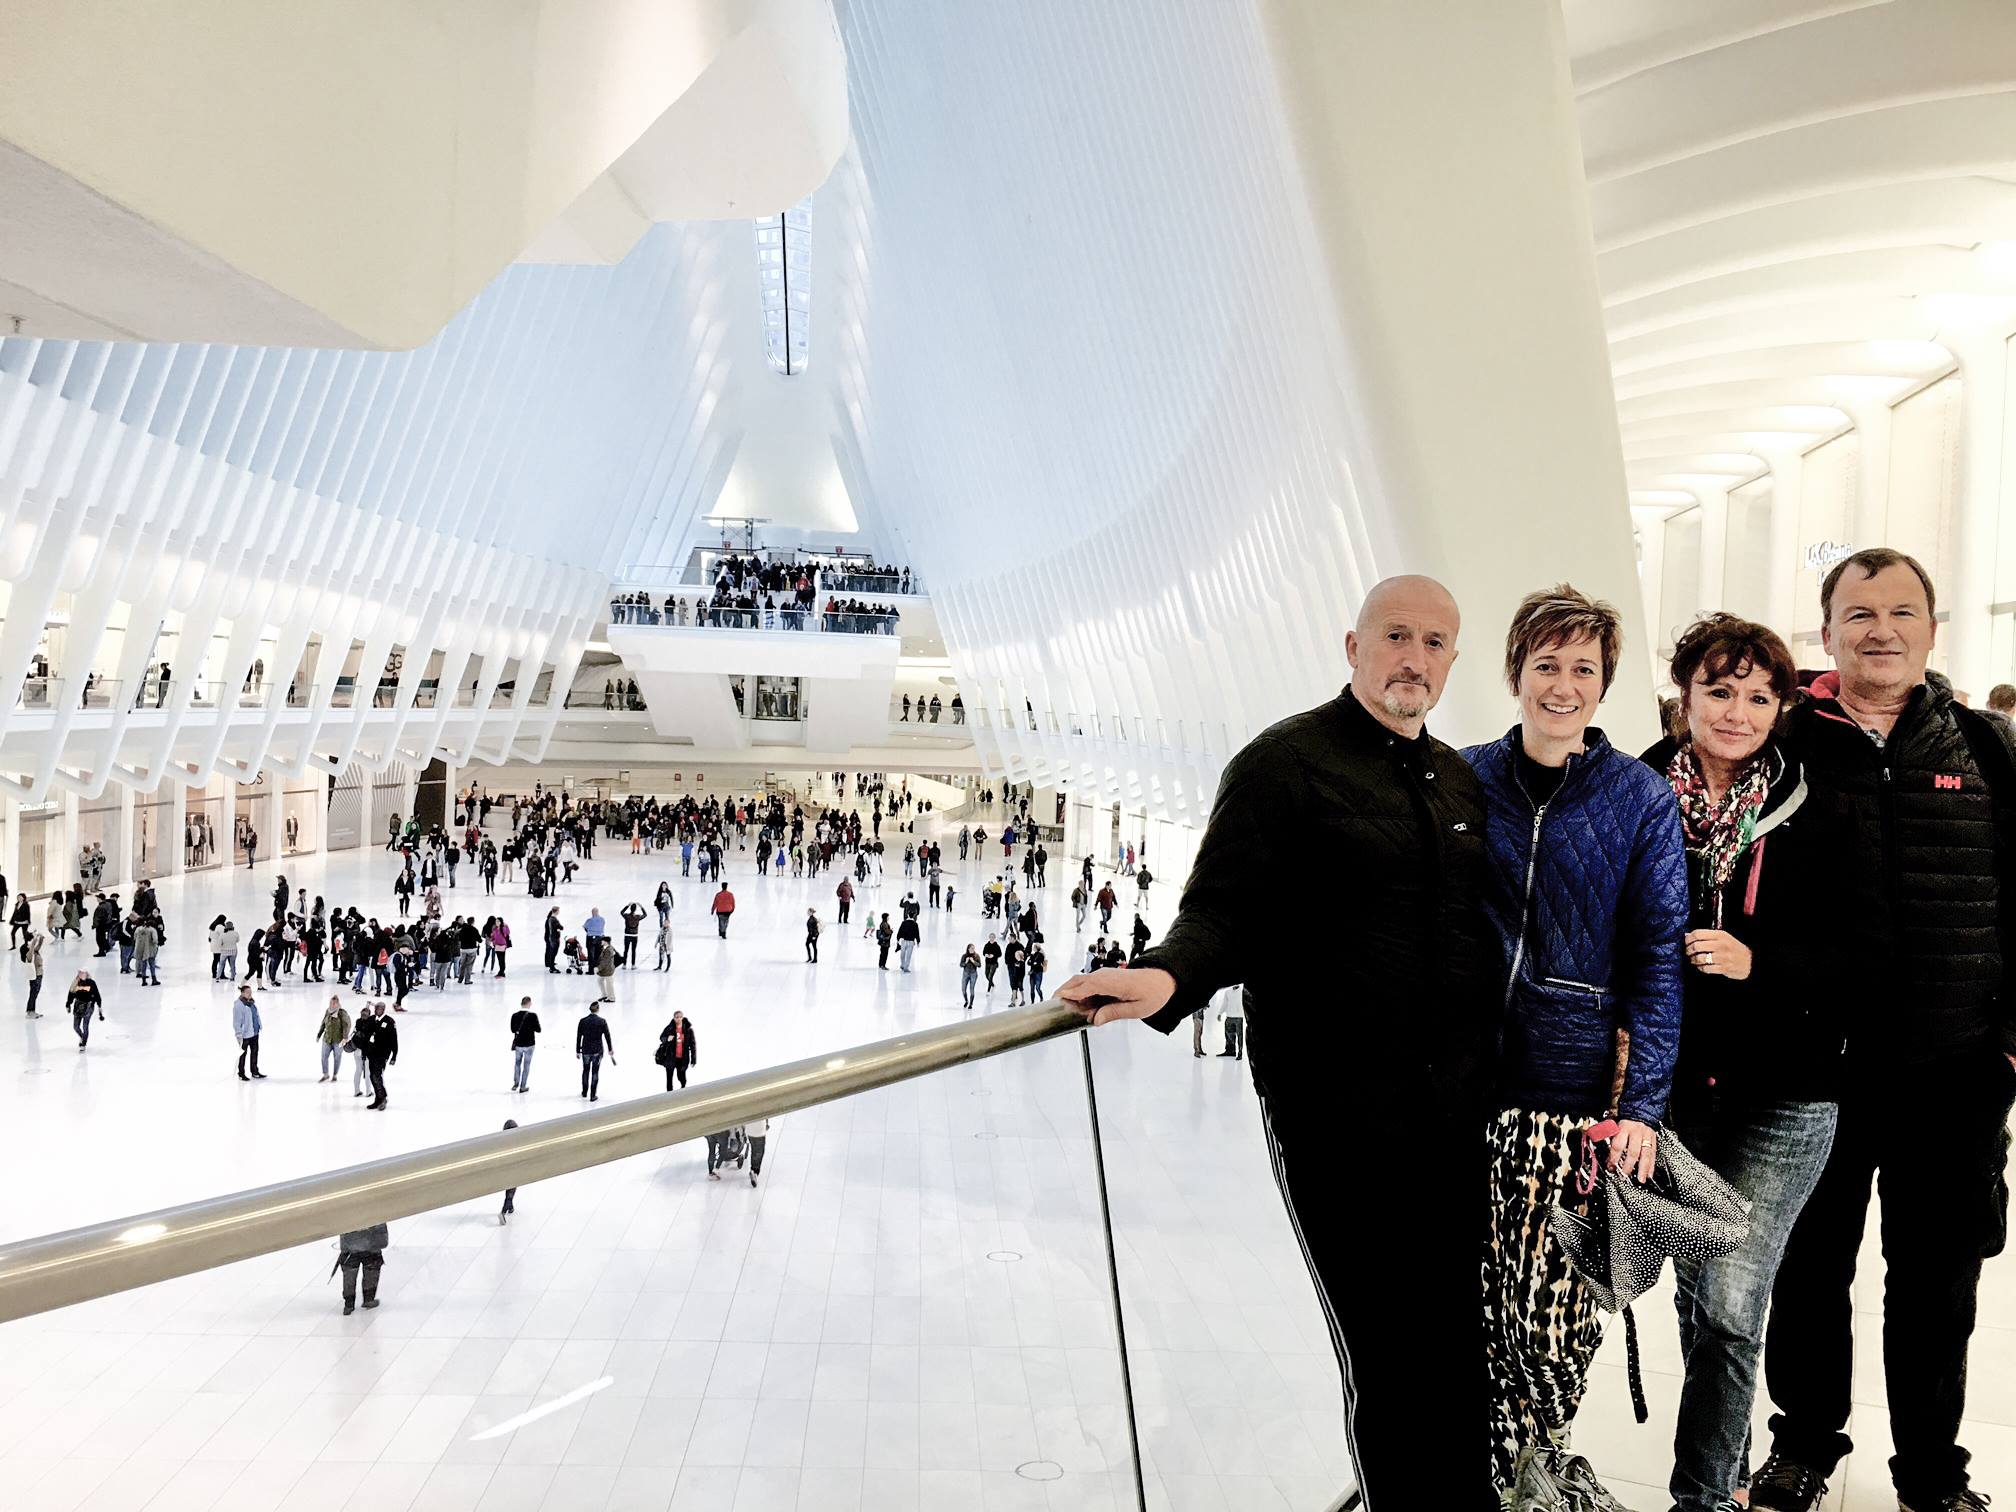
[{"left": 1056, "top": 577, "right": 1498, "bottom": 1512}]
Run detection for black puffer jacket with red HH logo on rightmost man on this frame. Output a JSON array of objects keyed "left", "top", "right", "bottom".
[{"left": 1784, "top": 673, "right": 2016, "bottom": 1073}]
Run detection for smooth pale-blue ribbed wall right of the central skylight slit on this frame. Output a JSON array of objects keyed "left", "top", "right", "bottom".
[{"left": 818, "top": 0, "right": 1375, "bottom": 818}]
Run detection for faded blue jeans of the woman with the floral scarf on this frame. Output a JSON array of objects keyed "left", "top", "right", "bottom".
[{"left": 1667, "top": 1101, "right": 1841, "bottom": 1512}]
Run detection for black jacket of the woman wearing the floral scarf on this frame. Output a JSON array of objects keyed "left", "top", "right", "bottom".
[{"left": 1643, "top": 740, "right": 1853, "bottom": 1125}]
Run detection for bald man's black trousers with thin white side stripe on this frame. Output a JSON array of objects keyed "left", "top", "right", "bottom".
[{"left": 1260, "top": 1091, "right": 1500, "bottom": 1512}]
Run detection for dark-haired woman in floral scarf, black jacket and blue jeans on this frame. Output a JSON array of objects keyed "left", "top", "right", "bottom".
[{"left": 1645, "top": 615, "right": 1847, "bottom": 1512}]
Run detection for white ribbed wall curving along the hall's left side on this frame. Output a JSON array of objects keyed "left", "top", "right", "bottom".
[{"left": 0, "top": 226, "right": 750, "bottom": 798}]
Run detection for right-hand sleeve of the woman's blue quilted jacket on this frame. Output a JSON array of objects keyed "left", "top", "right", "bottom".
[{"left": 1617, "top": 778, "right": 1687, "bottom": 1123}]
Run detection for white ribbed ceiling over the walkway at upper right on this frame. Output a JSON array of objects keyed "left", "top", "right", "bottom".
[{"left": 1564, "top": 0, "right": 2016, "bottom": 510}]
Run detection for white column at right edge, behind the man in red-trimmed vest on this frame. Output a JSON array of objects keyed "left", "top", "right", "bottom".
[{"left": 1939, "top": 329, "right": 2008, "bottom": 706}]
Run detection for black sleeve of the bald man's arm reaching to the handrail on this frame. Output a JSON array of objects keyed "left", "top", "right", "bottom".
[{"left": 1133, "top": 736, "right": 1306, "bottom": 1034}]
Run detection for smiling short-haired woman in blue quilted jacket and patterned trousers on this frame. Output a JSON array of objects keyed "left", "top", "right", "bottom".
[{"left": 1464, "top": 585, "right": 1687, "bottom": 1492}]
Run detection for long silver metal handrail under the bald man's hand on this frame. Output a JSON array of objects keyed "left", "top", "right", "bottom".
[{"left": 0, "top": 998, "right": 1085, "bottom": 1322}]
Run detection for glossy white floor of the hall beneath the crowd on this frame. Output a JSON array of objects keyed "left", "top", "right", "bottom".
[{"left": 0, "top": 794, "right": 2016, "bottom": 1512}]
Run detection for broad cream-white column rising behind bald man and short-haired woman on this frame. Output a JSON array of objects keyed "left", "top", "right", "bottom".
[{"left": 1260, "top": 0, "right": 1657, "bottom": 748}]
